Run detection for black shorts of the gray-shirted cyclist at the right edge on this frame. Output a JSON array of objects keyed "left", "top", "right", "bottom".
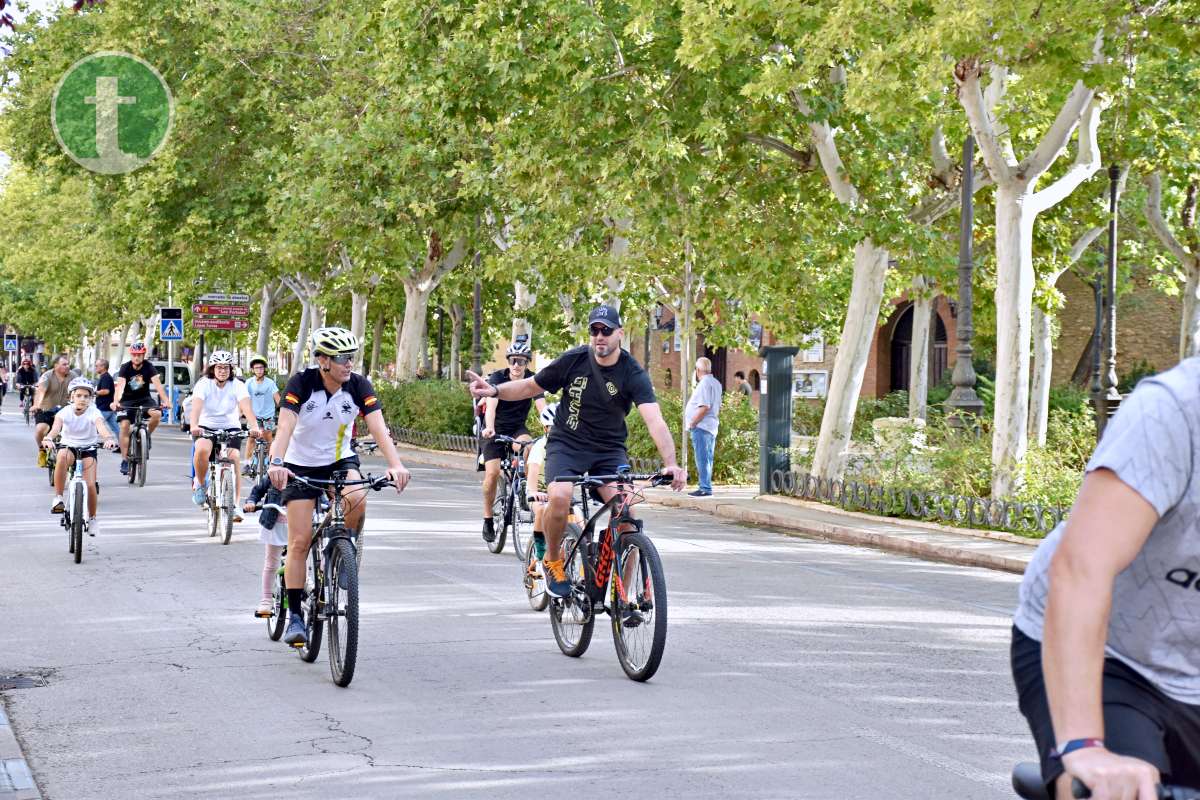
[{"left": 1012, "top": 626, "right": 1200, "bottom": 798}]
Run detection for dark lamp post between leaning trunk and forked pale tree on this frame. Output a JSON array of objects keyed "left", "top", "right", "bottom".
[{"left": 946, "top": 134, "right": 983, "bottom": 431}]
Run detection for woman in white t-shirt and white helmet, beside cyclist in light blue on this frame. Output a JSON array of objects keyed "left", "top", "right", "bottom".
[{"left": 190, "top": 350, "right": 262, "bottom": 522}]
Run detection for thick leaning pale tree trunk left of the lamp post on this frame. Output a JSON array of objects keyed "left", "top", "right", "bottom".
[{"left": 812, "top": 239, "right": 888, "bottom": 480}]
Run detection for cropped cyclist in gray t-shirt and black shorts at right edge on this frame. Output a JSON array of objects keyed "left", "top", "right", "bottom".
[{"left": 1012, "top": 359, "right": 1200, "bottom": 800}]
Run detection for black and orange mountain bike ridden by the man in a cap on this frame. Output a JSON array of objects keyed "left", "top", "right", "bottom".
[{"left": 550, "top": 471, "right": 671, "bottom": 681}]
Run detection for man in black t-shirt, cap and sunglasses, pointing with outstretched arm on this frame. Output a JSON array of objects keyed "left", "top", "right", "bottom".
[{"left": 467, "top": 306, "right": 684, "bottom": 597}]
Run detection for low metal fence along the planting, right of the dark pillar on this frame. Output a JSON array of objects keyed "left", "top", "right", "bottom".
[{"left": 770, "top": 470, "right": 1067, "bottom": 534}]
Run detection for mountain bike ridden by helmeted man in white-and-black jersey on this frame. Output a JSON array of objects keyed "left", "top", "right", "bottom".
[{"left": 283, "top": 470, "right": 392, "bottom": 686}]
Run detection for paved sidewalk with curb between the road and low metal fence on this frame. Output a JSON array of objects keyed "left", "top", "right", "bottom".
[{"left": 397, "top": 445, "right": 1039, "bottom": 575}]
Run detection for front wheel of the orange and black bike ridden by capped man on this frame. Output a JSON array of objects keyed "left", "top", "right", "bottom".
[{"left": 610, "top": 533, "right": 667, "bottom": 681}]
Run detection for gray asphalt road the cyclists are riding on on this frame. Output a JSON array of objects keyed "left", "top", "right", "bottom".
[{"left": 0, "top": 396, "right": 1033, "bottom": 800}]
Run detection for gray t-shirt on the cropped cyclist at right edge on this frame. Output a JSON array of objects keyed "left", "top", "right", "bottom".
[{"left": 1013, "top": 357, "right": 1200, "bottom": 705}]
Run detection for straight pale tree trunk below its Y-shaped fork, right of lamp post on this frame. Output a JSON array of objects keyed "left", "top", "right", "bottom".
[{"left": 991, "top": 185, "right": 1036, "bottom": 499}]
